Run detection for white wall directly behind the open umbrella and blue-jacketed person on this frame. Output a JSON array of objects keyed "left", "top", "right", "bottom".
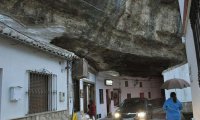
[{"left": 162, "top": 63, "right": 192, "bottom": 102}]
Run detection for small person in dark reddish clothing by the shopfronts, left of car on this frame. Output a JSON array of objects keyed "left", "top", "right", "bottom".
[{"left": 88, "top": 100, "right": 96, "bottom": 120}]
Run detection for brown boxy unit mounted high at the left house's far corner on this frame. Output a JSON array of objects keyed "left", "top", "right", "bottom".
[{"left": 72, "top": 58, "right": 88, "bottom": 79}]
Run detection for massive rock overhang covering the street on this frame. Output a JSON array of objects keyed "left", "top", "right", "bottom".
[{"left": 0, "top": 0, "right": 186, "bottom": 76}]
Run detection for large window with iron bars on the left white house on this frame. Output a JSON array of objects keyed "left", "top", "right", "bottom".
[{"left": 29, "top": 71, "right": 57, "bottom": 114}]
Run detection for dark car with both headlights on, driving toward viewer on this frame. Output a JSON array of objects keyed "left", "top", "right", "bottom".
[{"left": 113, "top": 98, "right": 152, "bottom": 120}]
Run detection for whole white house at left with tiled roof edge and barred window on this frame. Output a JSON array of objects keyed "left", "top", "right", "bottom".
[{"left": 0, "top": 17, "right": 75, "bottom": 120}]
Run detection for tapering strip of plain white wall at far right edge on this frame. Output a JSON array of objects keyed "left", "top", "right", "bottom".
[{"left": 185, "top": 22, "right": 200, "bottom": 120}]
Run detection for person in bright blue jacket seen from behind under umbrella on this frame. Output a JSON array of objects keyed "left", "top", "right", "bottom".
[{"left": 163, "top": 92, "right": 183, "bottom": 120}]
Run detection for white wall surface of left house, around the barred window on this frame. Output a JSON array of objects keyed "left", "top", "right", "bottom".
[{"left": 0, "top": 38, "right": 67, "bottom": 120}]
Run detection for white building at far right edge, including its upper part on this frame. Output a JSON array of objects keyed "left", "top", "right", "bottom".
[{"left": 179, "top": 0, "right": 200, "bottom": 120}]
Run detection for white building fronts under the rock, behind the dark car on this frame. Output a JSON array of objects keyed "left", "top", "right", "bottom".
[{"left": 96, "top": 76, "right": 164, "bottom": 118}]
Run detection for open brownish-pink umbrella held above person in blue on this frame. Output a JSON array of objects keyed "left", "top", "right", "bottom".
[{"left": 161, "top": 78, "right": 190, "bottom": 90}]
